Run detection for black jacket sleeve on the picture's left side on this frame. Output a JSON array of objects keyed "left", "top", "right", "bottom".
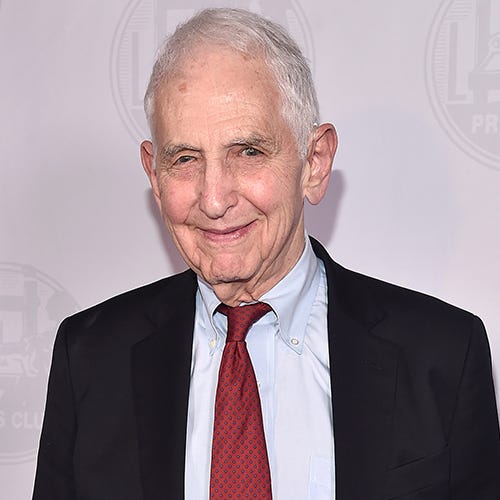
[{"left": 33, "top": 320, "right": 76, "bottom": 500}]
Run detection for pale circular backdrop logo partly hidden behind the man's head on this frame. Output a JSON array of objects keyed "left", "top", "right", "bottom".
[{"left": 110, "top": 0, "right": 314, "bottom": 142}]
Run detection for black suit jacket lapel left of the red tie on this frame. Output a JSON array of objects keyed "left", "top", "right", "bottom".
[{"left": 132, "top": 271, "right": 197, "bottom": 500}]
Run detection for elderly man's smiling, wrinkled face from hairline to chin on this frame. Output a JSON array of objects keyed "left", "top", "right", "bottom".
[{"left": 142, "top": 48, "right": 332, "bottom": 303}]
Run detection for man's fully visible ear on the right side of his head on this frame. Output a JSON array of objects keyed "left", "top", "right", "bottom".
[{"left": 303, "top": 123, "right": 338, "bottom": 205}]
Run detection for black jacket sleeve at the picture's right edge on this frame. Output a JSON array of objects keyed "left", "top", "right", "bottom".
[{"left": 449, "top": 318, "right": 500, "bottom": 500}]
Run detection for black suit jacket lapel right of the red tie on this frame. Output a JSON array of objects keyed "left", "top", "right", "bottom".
[{"left": 313, "top": 241, "right": 398, "bottom": 500}]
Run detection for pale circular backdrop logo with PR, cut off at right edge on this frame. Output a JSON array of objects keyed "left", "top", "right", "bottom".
[{"left": 426, "top": 0, "right": 500, "bottom": 169}]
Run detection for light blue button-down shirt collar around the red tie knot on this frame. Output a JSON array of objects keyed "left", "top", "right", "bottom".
[{"left": 198, "top": 235, "right": 320, "bottom": 354}]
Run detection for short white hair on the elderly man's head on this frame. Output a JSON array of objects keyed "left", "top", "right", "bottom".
[{"left": 144, "top": 8, "right": 319, "bottom": 157}]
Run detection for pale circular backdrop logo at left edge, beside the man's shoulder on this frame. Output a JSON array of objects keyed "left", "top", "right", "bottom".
[{"left": 0, "top": 263, "right": 78, "bottom": 464}]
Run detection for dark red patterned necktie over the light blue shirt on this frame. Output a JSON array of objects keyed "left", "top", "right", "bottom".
[{"left": 210, "top": 302, "right": 272, "bottom": 500}]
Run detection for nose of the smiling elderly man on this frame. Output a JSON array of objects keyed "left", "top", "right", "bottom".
[{"left": 199, "top": 160, "right": 238, "bottom": 219}]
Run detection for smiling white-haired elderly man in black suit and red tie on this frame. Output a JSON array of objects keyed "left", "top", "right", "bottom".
[{"left": 33, "top": 9, "right": 500, "bottom": 500}]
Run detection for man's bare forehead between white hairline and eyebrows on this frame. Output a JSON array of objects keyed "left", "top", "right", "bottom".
[{"left": 154, "top": 46, "right": 282, "bottom": 137}]
